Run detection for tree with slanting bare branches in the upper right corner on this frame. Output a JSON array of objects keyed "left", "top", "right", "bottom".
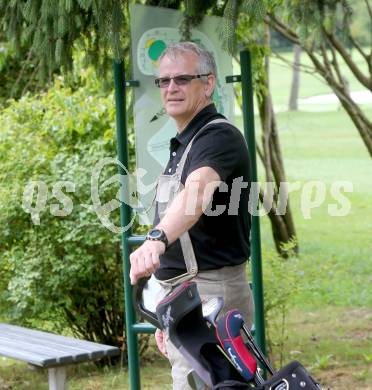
[{"left": 265, "top": 0, "right": 372, "bottom": 157}]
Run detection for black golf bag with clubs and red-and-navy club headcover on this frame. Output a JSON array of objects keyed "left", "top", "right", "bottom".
[{"left": 136, "top": 281, "right": 321, "bottom": 390}]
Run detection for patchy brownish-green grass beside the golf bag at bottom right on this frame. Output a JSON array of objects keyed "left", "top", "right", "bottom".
[{"left": 284, "top": 305, "right": 372, "bottom": 390}]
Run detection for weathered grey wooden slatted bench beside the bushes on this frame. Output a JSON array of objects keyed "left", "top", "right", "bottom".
[{"left": 0, "top": 323, "right": 120, "bottom": 390}]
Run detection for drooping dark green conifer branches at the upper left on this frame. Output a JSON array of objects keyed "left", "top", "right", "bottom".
[{"left": 0, "top": 0, "right": 129, "bottom": 98}]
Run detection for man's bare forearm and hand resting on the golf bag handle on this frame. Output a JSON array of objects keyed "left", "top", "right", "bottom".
[{"left": 130, "top": 167, "right": 221, "bottom": 284}]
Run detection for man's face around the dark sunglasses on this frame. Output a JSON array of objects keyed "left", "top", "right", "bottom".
[{"left": 159, "top": 52, "right": 215, "bottom": 130}]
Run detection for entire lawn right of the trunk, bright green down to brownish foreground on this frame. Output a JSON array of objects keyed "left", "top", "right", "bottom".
[{"left": 261, "top": 106, "right": 372, "bottom": 390}]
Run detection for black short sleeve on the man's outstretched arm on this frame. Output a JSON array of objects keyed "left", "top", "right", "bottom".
[{"left": 186, "top": 126, "right": 247, "bottom": 181}]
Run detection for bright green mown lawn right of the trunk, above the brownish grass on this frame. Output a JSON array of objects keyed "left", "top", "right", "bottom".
[{"left": 261, "top": 111, "right": 372, "bottom": 307}]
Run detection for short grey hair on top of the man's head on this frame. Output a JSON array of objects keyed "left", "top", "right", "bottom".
[{"left": 159, "top": 42, "right": 217, "bottom": 77}]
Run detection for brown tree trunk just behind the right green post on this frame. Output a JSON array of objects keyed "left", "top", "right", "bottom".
[{"left": 257, "top": 26, "right": 298, "bottom": 257}]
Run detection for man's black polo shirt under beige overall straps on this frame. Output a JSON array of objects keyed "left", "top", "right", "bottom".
[{"left": 154, "top": 104, "right": 251, "bottom": 280}]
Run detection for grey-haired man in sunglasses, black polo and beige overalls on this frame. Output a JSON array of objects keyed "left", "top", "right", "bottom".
[{"left": 130, "top": 42, "right": 253, "bottom": 390}]
